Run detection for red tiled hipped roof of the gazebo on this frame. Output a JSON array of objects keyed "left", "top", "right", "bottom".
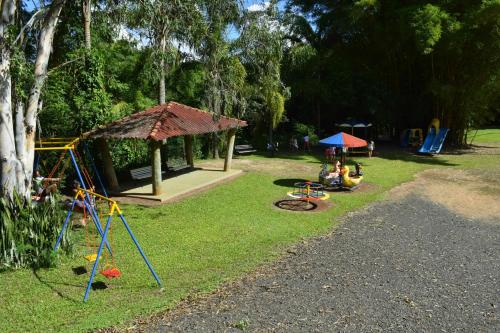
[{"left": 84, "top": 102, "right": 247, "bottom": 141}]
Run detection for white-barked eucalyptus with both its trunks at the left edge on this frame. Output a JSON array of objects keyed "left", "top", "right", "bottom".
[{"left": 0, "top": 0, "right": 66, "bottom": 198}]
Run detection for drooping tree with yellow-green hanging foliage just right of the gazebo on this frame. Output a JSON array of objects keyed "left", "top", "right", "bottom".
[{"left": 237, "top": 1, "right": 289, "bottom": 151}]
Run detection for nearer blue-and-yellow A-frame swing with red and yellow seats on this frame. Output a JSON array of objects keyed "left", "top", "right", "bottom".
[{"left": 54, "top": 189, "right": 161, "bottom": 302}]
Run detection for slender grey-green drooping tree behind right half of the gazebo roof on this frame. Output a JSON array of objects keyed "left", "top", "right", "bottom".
[{"left": 199, "top": 0, "right": 246, "bottom": 158}]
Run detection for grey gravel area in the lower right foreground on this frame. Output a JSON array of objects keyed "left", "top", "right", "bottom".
[{"left": 137, "top": 194, "right": 500, "bottom": 332}]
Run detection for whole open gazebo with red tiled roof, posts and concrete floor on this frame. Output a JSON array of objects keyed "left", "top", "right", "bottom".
[{"left": 84, "top": 102, "right": 247, "bottom": 201}]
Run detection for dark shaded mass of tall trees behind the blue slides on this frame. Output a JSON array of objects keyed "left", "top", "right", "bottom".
[{"left": 283, "top": 0, "right": 500, "bottom": 144}]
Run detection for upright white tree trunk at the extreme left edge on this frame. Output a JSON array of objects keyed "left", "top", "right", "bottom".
[{"left": 0, "top": 0, "right": 17, "bottom": 197}]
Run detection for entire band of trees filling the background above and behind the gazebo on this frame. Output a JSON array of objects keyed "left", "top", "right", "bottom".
[{"left": 0, "top": 0, "right": 500, "bottom": 194}]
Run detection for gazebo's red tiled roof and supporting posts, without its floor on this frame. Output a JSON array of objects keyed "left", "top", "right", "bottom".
[{"left": 84, "top": 102, "right": 247, "bottom": 195}]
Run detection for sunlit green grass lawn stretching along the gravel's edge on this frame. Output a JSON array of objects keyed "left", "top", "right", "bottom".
[{"left": 0, "top": 143, "right": 499, "bottom": 332}]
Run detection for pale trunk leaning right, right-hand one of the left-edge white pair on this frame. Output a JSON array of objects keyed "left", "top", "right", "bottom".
[{"left": 25, "top": 0, "right": 66, "bottom": 195}]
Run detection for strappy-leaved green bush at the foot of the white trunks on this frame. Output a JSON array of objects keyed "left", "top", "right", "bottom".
[{"left": 0, "top": 194, "right": 71, "bottom": 270}]
